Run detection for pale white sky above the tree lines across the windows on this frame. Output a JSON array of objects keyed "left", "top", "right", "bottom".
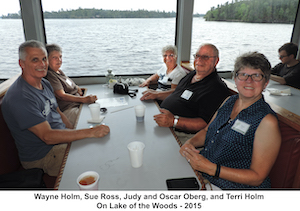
[{"left": 0, "top": 0, "right": 232, "bottom": 16}]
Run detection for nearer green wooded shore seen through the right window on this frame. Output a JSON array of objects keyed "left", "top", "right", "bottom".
[{"left": 204, "top": 0, "right": 298, "bottom": 23}]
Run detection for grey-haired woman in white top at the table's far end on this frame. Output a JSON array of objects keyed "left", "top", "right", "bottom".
[{"left": 140, "top": 45, "right": 186, "bottom": 91}]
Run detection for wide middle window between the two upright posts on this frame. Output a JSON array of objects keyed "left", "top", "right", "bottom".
[{"left": 43, "top": 0, "right": 176, "bottom": 76}]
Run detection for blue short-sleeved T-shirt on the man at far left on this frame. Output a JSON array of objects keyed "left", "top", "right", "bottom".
[{"left": 2, "top": 76, "right": 65, "bottom": 161}]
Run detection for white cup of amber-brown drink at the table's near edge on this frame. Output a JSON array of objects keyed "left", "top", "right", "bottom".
[{"left": 77, "top": 171, "right": 99, "bottom": 190}]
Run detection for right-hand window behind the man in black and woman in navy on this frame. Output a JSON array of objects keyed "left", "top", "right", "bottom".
[{"left": 191, "top": 0, "right": 298, "bottom": 71}]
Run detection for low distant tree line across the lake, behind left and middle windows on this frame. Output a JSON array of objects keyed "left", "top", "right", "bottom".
[{"left": 2, "top": 8, "right": 176, "bottom": 19}]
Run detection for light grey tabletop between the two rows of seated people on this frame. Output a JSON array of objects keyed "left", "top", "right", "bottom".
[{"left": 58, "top": 85, "right": 206, "bottom": 190}]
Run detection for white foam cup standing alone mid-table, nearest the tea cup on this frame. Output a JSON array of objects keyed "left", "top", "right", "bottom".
[{"left": 127, "top": 141, "right": 145, "bottom": 168}]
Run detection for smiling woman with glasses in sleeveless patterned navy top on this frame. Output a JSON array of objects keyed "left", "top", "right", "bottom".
[{"left": 180, "top": 52, "right": 281, "bottom": 189}]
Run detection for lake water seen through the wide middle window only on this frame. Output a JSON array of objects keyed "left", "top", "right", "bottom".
[{"left": 45, "top": 18, "right": 175, "bottom": 76}]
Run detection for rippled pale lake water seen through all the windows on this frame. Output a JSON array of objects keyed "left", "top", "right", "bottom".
[{"left": 0, "top": 18, "right": 293, "bottom": 79}]
